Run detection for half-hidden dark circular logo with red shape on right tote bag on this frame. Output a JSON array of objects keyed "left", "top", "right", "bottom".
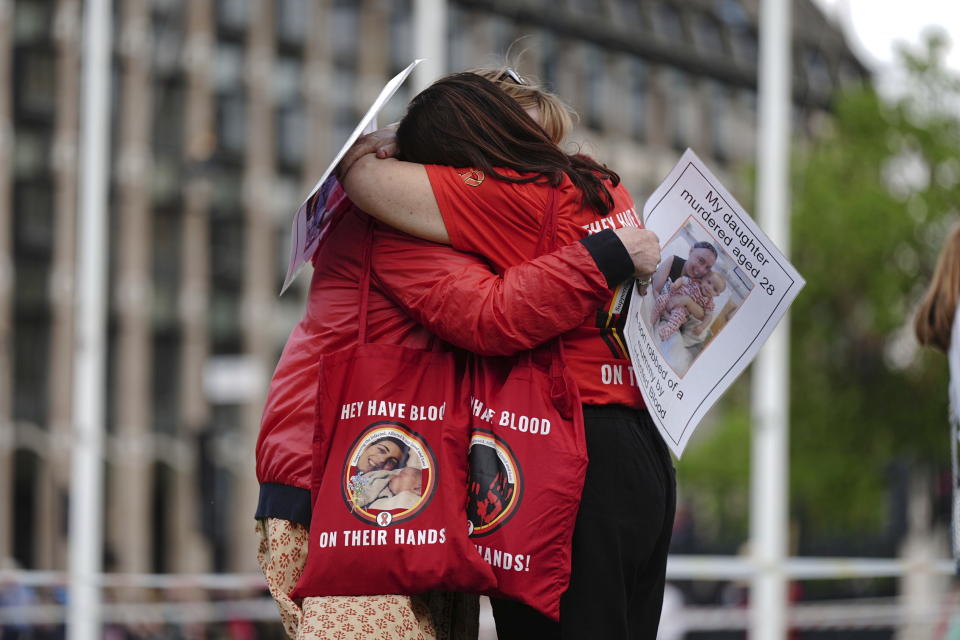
[{"left": 467, "top": 429, "right": 523, "bottom": 538}]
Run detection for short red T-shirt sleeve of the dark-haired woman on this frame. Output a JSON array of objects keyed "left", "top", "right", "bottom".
[{"left": 426, "top": 165, "right": 547, "bottom": 271}]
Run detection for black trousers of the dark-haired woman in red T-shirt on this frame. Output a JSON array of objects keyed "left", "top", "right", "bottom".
[{"left": 493, "top": 406, "right": 677, "bottom": 640}]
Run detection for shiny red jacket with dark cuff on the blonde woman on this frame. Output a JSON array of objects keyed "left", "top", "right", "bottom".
[{"left": 256, "top": 209, "right": 633, "bottom": 521}]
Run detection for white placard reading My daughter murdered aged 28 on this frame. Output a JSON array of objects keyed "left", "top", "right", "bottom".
[{"left": 625, "top": 149, "right": 806, "bottom": 457}]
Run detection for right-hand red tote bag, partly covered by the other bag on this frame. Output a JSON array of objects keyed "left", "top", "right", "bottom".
[{"left": 467, "top": 190, "right": 587, "bottom": 620}]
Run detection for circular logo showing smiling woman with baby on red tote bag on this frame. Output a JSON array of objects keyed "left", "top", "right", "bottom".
[{"left": 342, "top": 421, "right": 437, "bottom": 527}]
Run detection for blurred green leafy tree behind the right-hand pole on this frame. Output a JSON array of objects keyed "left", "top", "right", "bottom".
[{"left": 680, "top": 35, "right": 960, "bottom": 537}]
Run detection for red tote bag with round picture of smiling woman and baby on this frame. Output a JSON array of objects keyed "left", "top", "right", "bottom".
[{"left": 291, "top": 221, "right": 494, "bottom": 598}]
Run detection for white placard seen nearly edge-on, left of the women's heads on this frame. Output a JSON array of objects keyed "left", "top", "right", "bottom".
[{"left": 280, "top": 59, "right": 423, "bottom": 295}]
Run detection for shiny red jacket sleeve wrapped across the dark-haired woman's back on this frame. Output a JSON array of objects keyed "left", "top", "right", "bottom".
[{"left": 373, "top": 228, "right": 610, "bottom": 355}]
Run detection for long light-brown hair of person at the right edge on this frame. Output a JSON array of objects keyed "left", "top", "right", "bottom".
[{"left": 913, "top": 225, "right": 960, "bottom": 351}]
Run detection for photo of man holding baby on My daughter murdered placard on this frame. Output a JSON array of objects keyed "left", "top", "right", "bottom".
[{"left": 641, "top": 216, "right": 754, "bottom": 378}]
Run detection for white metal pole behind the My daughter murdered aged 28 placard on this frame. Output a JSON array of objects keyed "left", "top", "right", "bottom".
[{"left": 750, "top": 0, "right": 792, "bottom": 640}]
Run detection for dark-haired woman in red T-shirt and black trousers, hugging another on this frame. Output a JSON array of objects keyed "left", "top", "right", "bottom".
[{"left": 343, "top": 73, "right": 676, "bottom": 640}]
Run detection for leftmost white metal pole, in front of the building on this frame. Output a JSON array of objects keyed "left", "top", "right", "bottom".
[{"left": 67, "top": 0, "right": 111, "bottom": 640}]
